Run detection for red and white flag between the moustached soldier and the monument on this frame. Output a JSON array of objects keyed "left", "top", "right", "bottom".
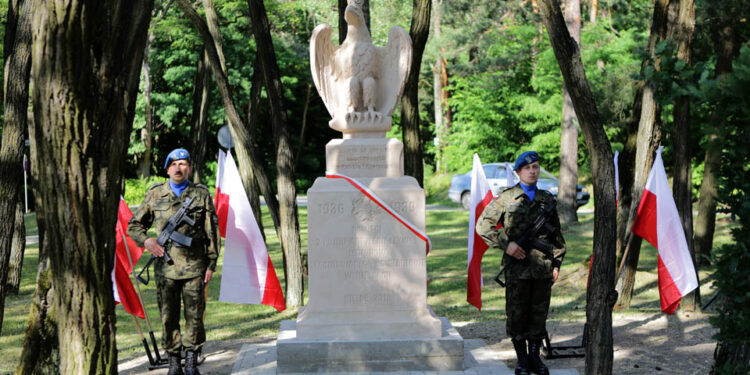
[{"left": 215, "top": 151, "right": 286, "bottom": 311}]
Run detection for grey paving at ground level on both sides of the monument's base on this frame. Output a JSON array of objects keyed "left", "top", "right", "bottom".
[{"left": 232, "top": 340, "right": 579, "bottom": 375}]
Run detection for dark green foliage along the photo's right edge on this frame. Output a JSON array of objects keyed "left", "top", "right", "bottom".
[{"left": 709, "top": 46, "right": 750, "bottom": 373}]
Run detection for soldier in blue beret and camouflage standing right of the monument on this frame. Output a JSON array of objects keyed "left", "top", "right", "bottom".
[{"left": 476, "top": 151, "right": 565, "bottom": 375}]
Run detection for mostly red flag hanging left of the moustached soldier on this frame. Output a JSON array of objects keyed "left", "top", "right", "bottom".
[{"left": 112, "top": 197, "right": 146, "bottom": 319}]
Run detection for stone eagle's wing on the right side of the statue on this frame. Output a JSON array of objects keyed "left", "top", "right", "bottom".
[{"left": 376, "top": 26, "right": 412, "bottom": 116}]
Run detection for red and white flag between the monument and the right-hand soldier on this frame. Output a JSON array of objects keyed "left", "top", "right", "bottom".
[{"left": 466, "top": 154, "right": 496, "bottom": 310}]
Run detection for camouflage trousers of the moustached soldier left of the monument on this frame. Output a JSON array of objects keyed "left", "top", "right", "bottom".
[{"left": 156, "top": 276, "right": 206, "bottom": 354}]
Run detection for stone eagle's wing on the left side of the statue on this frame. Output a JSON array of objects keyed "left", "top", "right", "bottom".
[{"left": 310, "top": 24, "right": 338, "bottom": 117}]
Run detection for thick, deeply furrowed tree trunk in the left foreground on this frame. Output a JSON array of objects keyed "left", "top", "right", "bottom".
[{"left": 27, "top": 0, "right": 153, "bottom": 374}]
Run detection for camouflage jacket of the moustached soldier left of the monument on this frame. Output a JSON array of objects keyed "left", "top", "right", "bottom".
[{"left": 128, "top": 182, "right": 221, "bottom": 279}]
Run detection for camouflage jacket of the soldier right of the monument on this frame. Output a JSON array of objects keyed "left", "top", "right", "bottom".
[{"left": 476, "top": 184, "right": 565, "bottom": 279}]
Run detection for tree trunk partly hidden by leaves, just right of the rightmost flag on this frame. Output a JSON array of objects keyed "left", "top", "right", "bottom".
[{"left": 693, "top": 22, "right": 740, "bottom": 265}]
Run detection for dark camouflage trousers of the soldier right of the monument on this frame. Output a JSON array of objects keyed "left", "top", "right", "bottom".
[{"left": 505, "top": 278, "right": 552, "bottom": 340}]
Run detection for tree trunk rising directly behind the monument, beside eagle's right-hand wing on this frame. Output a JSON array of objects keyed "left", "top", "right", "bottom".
[{"left": 401, "top": 0, "right": 432, "bottom": 186}]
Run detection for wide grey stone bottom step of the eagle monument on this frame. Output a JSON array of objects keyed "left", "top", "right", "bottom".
[{"left": 276, "top": 318, "right": 464, "bottom": 374}]
